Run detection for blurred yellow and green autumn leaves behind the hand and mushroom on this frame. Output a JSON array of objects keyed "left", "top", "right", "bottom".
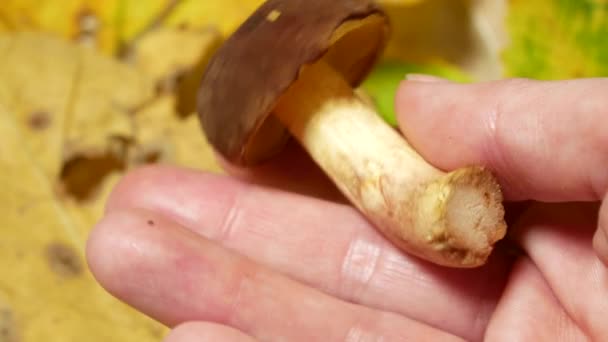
[{"left": 0, "top": 0, "right": 608, "bottom": 342}]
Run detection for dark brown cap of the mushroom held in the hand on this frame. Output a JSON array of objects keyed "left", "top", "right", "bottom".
[{"left": 198, "top": 0, "right": 389, "bottom": 165}]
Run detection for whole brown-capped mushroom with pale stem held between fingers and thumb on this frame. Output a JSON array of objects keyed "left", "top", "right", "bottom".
[{"left": 198, "top": 0, "right": 506, "bottom": 268}]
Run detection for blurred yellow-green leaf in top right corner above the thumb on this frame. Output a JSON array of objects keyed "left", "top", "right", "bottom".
[{"left": 503, "top": 0, "right": 608, "bottom": 80}]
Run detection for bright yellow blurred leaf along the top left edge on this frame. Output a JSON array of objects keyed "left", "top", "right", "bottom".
[{"left": 0, "top": 0, "right": 262, "bottom": 55}]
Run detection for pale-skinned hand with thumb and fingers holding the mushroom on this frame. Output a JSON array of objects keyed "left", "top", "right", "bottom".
[{"left": 87, "top": 77, "right": 608, "bottom": 342}]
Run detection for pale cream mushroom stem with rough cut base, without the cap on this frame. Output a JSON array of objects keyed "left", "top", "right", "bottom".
[{"left": 275, "top": 61, "right": 506, "bottom": 268}]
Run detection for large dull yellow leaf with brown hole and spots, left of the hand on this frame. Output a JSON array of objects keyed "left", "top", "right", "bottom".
[{"left": 0, "top": 32, "right": 220, "bottom": 342}]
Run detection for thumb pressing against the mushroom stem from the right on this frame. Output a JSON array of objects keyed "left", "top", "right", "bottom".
[{"left": 396, "top": 78, "right": 608, "bottom": 202}]
